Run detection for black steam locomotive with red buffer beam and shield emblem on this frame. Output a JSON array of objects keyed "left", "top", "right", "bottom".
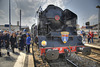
[{"left": 32, "top": 5, "right": 91, "bottom": 60}]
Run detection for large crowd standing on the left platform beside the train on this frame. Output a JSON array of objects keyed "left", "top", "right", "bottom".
[{"left": 0, "top": 31, "right": 31, "bottom": 57}]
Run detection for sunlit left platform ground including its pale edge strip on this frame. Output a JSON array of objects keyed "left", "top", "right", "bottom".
[{"left": 0, "top": 46, "right": 34, "bottom": 67}]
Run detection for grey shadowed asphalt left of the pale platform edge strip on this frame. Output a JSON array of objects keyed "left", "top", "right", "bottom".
[{"left": 0, "top": 48, "right": 20, "bottom": 67}]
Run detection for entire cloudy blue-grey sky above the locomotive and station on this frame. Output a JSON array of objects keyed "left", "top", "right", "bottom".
[{"left": 0, "top": 0, "right": 100, "bottom": 27}]
